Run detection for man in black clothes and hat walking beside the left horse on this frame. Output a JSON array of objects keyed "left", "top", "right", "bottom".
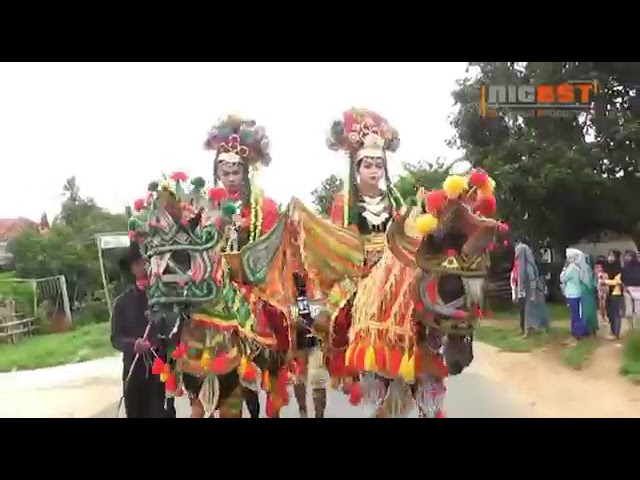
[{"left": 111, "top": 244, "right": 175, "bottom": 418}]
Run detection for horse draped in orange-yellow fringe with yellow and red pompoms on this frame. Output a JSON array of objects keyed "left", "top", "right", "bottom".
[{"left": 345, "top": 171, "right": 506, "bottom": 418}]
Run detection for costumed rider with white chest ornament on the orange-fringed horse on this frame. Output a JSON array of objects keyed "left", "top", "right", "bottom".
[{"left": 327, "top": 108, "right": 404, "bottom": 404}]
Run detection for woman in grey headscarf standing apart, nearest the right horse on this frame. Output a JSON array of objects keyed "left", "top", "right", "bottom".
[{"left": 511, "top": 243, "right": 549, "bottom": 335}]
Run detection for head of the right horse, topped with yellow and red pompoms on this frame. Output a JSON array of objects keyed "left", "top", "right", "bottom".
[{"left": 387, "top": 171, "right": 505, "bottom": 375}]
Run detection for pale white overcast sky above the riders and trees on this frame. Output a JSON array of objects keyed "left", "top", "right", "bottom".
[{"left": 0, "top": 62, "right": 466, "bottom": 220}]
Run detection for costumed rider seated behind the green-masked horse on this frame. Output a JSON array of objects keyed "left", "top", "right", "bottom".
[{"left": 205, "top": 115, "right": 289, "bottom": 418}]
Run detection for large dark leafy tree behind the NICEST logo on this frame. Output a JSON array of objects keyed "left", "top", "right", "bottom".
[{"left": 451, "top": 62, "right": 640, "bottom": 246}]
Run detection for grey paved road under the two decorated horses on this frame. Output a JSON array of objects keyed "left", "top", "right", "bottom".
[{"left": 94, "top": 370, "right": 528, "bottom": 418}]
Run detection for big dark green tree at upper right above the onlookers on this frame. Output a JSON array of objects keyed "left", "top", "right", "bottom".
[{"left": 451, "top": 62, "right": 637, "bottom": 247}]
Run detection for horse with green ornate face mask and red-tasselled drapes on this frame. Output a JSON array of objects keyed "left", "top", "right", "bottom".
[{"left": 129, "top": 173, "right": 287, "bottom": 418}]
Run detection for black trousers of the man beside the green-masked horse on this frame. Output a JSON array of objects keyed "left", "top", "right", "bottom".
[{"left": 124, "top": 375, "right": 171, "bottom": 418}]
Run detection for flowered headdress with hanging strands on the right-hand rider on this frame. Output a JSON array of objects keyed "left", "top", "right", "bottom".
[{"left": 327, "top": 108, "right": 403, "bottom": 226}]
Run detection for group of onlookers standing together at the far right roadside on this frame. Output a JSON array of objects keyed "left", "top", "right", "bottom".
[{"left": 560, "top": 248, "right": 640, "bottom": 340}]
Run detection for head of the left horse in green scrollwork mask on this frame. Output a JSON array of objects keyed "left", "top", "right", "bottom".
[{"left": 129, "top": 173, "right": 230, "bottom": 341}]
